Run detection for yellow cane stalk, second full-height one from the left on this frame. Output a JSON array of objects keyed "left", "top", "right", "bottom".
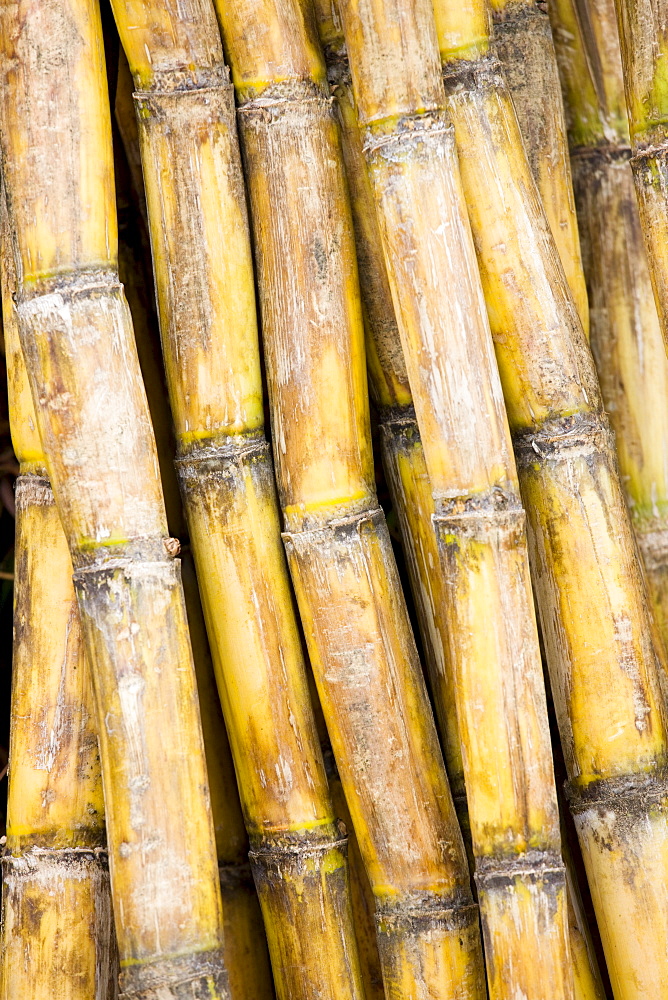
[{"left": 109, "top": 0, "right": 363, "bottom": 1000}]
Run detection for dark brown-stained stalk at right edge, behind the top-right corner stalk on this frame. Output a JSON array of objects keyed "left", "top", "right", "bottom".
[{"left": 551, "top": 0, "right": 668, "bottom": 692}]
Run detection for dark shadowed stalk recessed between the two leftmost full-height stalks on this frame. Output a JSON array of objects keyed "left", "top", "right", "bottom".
[{"left": 114, "top": 82, "right": 273, "bottom": 1000}]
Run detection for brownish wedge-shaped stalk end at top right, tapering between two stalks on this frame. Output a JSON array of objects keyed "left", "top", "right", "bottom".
[{"left": 488, "top": 0, "right": 589, "bottom": 333}]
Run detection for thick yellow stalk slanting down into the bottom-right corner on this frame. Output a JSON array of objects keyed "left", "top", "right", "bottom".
[{"left": 437, "top": 0, "right": 668, "bottom": 998}]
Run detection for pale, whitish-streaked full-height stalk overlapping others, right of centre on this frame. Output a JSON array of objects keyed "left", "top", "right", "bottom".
[{"left": 343, "top": 2, "right": 572, "bottom": 998}]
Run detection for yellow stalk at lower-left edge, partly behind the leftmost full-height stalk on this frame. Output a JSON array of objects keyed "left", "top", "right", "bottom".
[{"left": 0, "top": 205, "right": 117, "bottom": 1000}]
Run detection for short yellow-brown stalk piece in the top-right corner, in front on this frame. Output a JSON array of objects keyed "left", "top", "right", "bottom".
[{"left": 615, "top": 0, "right": 668, "bottom": 356}]
